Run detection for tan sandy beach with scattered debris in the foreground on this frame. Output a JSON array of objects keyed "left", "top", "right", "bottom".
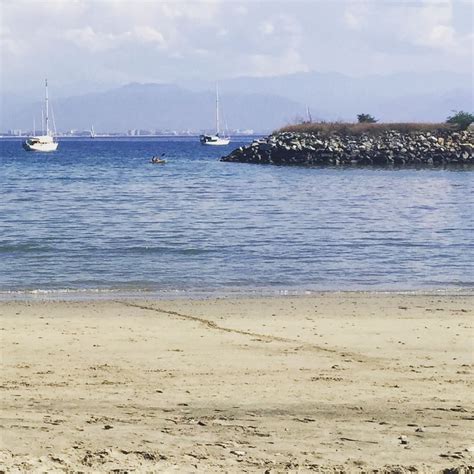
[{"left": 0, "top": 293, "right": 474, "bottom": 473}]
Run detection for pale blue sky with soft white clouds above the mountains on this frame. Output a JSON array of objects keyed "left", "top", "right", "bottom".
[{"left": 0, "top": 0, "right": 474, "bottom": 94}]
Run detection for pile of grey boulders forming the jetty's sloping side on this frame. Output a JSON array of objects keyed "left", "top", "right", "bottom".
[{"left": 221, "top": 130, "right": 474, "bottom": 168}]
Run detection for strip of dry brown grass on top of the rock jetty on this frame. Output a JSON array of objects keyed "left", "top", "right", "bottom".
[{"left": 276, "top": 122, "right": 456, "bottom": 135}]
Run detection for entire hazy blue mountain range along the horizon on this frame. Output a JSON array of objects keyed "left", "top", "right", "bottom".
[{"left": 0, "top": 72, "right": 474, "bottom": 133}]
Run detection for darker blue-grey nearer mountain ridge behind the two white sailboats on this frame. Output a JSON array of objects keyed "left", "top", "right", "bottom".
[{"left": 0, "top": 84, "right": 304, "bottom": 132}]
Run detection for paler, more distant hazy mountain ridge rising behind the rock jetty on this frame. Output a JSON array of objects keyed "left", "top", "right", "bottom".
[{"left": 189, "top": 72, "right": 473, "bottom": 122}]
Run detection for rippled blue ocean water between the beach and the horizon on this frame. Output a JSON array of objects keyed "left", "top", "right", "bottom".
[{"left": 0, "top": 138, "right": 474, "bottom": 295}]
